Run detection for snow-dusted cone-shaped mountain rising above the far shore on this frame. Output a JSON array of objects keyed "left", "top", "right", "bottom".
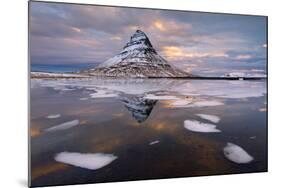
[{"left": 84, "top": 30, "right": 192, "bottom": 78}]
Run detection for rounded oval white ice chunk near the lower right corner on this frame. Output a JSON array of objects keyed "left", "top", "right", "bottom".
[{"left": 223, "top": 143, "right": 254, "bottom": 164}]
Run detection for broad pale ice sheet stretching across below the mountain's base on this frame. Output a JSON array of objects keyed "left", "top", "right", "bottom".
[{"left": 31, "top": 78, "right": 266, "bottom": 100}]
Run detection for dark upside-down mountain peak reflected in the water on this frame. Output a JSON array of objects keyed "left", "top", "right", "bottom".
[{"left": 121, "top": 96, "right": 157, "bottom": 123}]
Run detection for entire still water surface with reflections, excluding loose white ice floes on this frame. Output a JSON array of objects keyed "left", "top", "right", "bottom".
[{"left": 31, "top": 80, "right": 267, "bottom": 186}]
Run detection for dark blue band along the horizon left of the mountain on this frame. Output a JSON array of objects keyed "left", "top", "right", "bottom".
[{"left": 31, "top": 63, "right": 96, "bottom": 73}]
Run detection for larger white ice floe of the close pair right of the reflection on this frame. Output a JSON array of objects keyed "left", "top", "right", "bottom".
[{"left": 184, "top": 120, "right": 221, "bottom": 133}]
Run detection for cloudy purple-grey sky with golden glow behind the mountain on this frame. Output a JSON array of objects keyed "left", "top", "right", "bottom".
[{"left": 30, "top": 2, "right": 267, "bottom": 75}]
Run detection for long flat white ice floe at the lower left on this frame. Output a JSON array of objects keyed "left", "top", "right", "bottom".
[{"left": 55, "top": 152, "right": 118, "bottom": 170}]
